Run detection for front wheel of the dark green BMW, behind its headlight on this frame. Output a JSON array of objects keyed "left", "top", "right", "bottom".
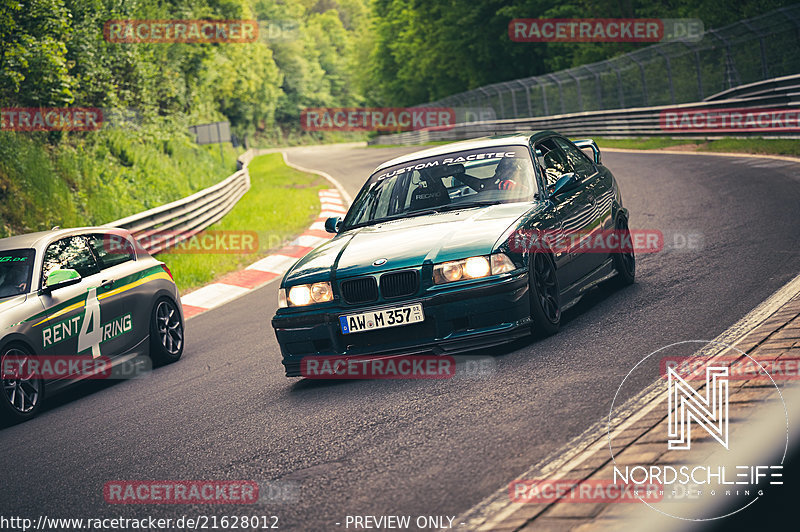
[{"left": 528, "top": 253, "right": 561, "bottom": 337}]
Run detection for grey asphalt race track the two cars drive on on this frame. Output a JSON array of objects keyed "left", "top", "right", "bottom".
[{"left": 0, "top": 143, "right": 800, "bottom": 530}]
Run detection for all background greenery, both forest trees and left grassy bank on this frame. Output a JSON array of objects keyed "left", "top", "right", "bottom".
[{"left": 0, "top": 0, "right": 797, "bottom": 237}]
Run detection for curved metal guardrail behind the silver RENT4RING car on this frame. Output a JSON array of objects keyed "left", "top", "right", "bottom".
[{"left": 105, "top": 150, "right": 253, "bottom": 253}]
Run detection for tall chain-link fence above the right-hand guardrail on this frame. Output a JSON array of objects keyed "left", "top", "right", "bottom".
[{"left": 424, "top": 4, "right": 800, "bottom": 122}]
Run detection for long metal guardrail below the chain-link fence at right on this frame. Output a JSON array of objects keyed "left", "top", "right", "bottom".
[{"left": 369, "top": 76, "right": 800, "bottom": 145}]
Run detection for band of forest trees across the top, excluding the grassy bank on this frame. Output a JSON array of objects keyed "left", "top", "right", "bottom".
[{"left": 0, "top": 0, "right": 790, "bottom": 137}]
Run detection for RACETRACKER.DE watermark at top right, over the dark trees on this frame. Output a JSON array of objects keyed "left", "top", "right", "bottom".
[{"left": 508, "top": 18, "right": 703, "bottom": 42}]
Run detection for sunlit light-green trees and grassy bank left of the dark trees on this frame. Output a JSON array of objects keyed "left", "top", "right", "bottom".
[{"left": 0, "top": 0, "right": 370, "bottom": 237}]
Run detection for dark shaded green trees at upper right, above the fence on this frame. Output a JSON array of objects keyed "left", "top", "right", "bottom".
[{"left": 361, "top": 0, "right": 797, "bottom": 106}]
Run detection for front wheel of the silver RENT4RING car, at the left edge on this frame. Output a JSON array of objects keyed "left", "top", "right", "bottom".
[{"left": 0, "top": 345, "right": 45, "bottom": 424}]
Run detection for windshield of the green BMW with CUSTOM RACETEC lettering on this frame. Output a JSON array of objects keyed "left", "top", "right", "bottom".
[{"left": 343, "top": 146, "right": 536, "bottom": 229}]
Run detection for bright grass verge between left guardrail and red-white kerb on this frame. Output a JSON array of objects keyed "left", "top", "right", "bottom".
[{"left": 157, "top": 153, "right": 329, "bottom": 293}]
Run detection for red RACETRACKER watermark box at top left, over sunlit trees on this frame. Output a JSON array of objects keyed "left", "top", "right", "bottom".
[{"left": 103, "top": 19, "right": 259, "bottom": 44}]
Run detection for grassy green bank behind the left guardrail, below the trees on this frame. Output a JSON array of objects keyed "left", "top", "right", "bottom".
[{"left": 0, "top": 127, "right": 236, "bottom": 238}]
